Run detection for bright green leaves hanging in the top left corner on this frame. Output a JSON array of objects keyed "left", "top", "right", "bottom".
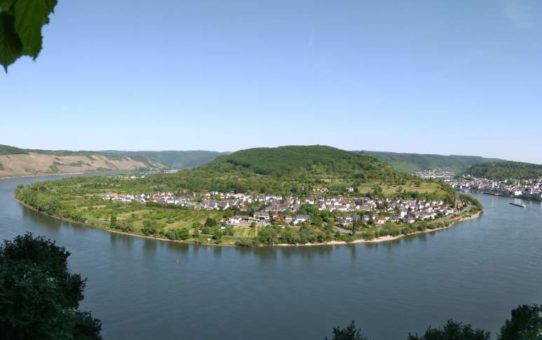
[{"left": 0, "top": 0, "right": 57, "bottom": 71}]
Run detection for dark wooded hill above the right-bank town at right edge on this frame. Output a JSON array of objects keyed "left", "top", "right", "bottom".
[{"left": 466, "top": 162, "right": 542, "bottom": 180}]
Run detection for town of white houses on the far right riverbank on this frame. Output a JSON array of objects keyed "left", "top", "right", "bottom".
[{"left": 446, "top": 176, "right": 542, "bottom": 201}]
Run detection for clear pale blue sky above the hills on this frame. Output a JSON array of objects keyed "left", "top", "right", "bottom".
[{"left": 0, "top": 0, "right": 542, "bottom": 163}]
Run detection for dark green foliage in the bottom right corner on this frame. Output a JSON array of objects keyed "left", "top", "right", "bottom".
[{"left": 499, "top": 305, "right": 542, "bottom": 340}]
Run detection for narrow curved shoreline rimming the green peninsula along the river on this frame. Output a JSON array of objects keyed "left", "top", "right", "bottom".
[{"left": 14, "top": 197, "right": 483, "bottom": 248}]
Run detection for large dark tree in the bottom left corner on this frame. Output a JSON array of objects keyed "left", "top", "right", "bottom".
[{"left": 0, "top": 233, "right": 101, "bottom": 339}]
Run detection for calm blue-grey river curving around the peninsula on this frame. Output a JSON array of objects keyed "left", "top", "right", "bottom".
[{"left": 0, "top": 179, "right": 542, "bottom": 339}]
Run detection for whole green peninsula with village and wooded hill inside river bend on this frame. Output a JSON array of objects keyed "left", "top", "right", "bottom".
[{"left": 16, "top": 145, "right": 481, "bottom": 246}]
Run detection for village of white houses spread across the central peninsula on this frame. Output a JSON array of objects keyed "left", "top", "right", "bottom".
[{"left": 103, "top": 192, "right": 457, "bottom": 226}]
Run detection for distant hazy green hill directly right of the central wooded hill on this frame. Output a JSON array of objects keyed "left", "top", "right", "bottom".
[{"left": 358, "top": 151, "right": 503, "bottom": 174}]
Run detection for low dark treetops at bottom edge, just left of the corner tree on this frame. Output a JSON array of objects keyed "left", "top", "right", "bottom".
[{"left": 407, "top": 320, "right": 490, "bottom": 340}]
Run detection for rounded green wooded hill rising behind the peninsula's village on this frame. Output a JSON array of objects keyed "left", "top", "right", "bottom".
[{"left": 135, "top": 145, "right": 450, "bottom": 197}]
